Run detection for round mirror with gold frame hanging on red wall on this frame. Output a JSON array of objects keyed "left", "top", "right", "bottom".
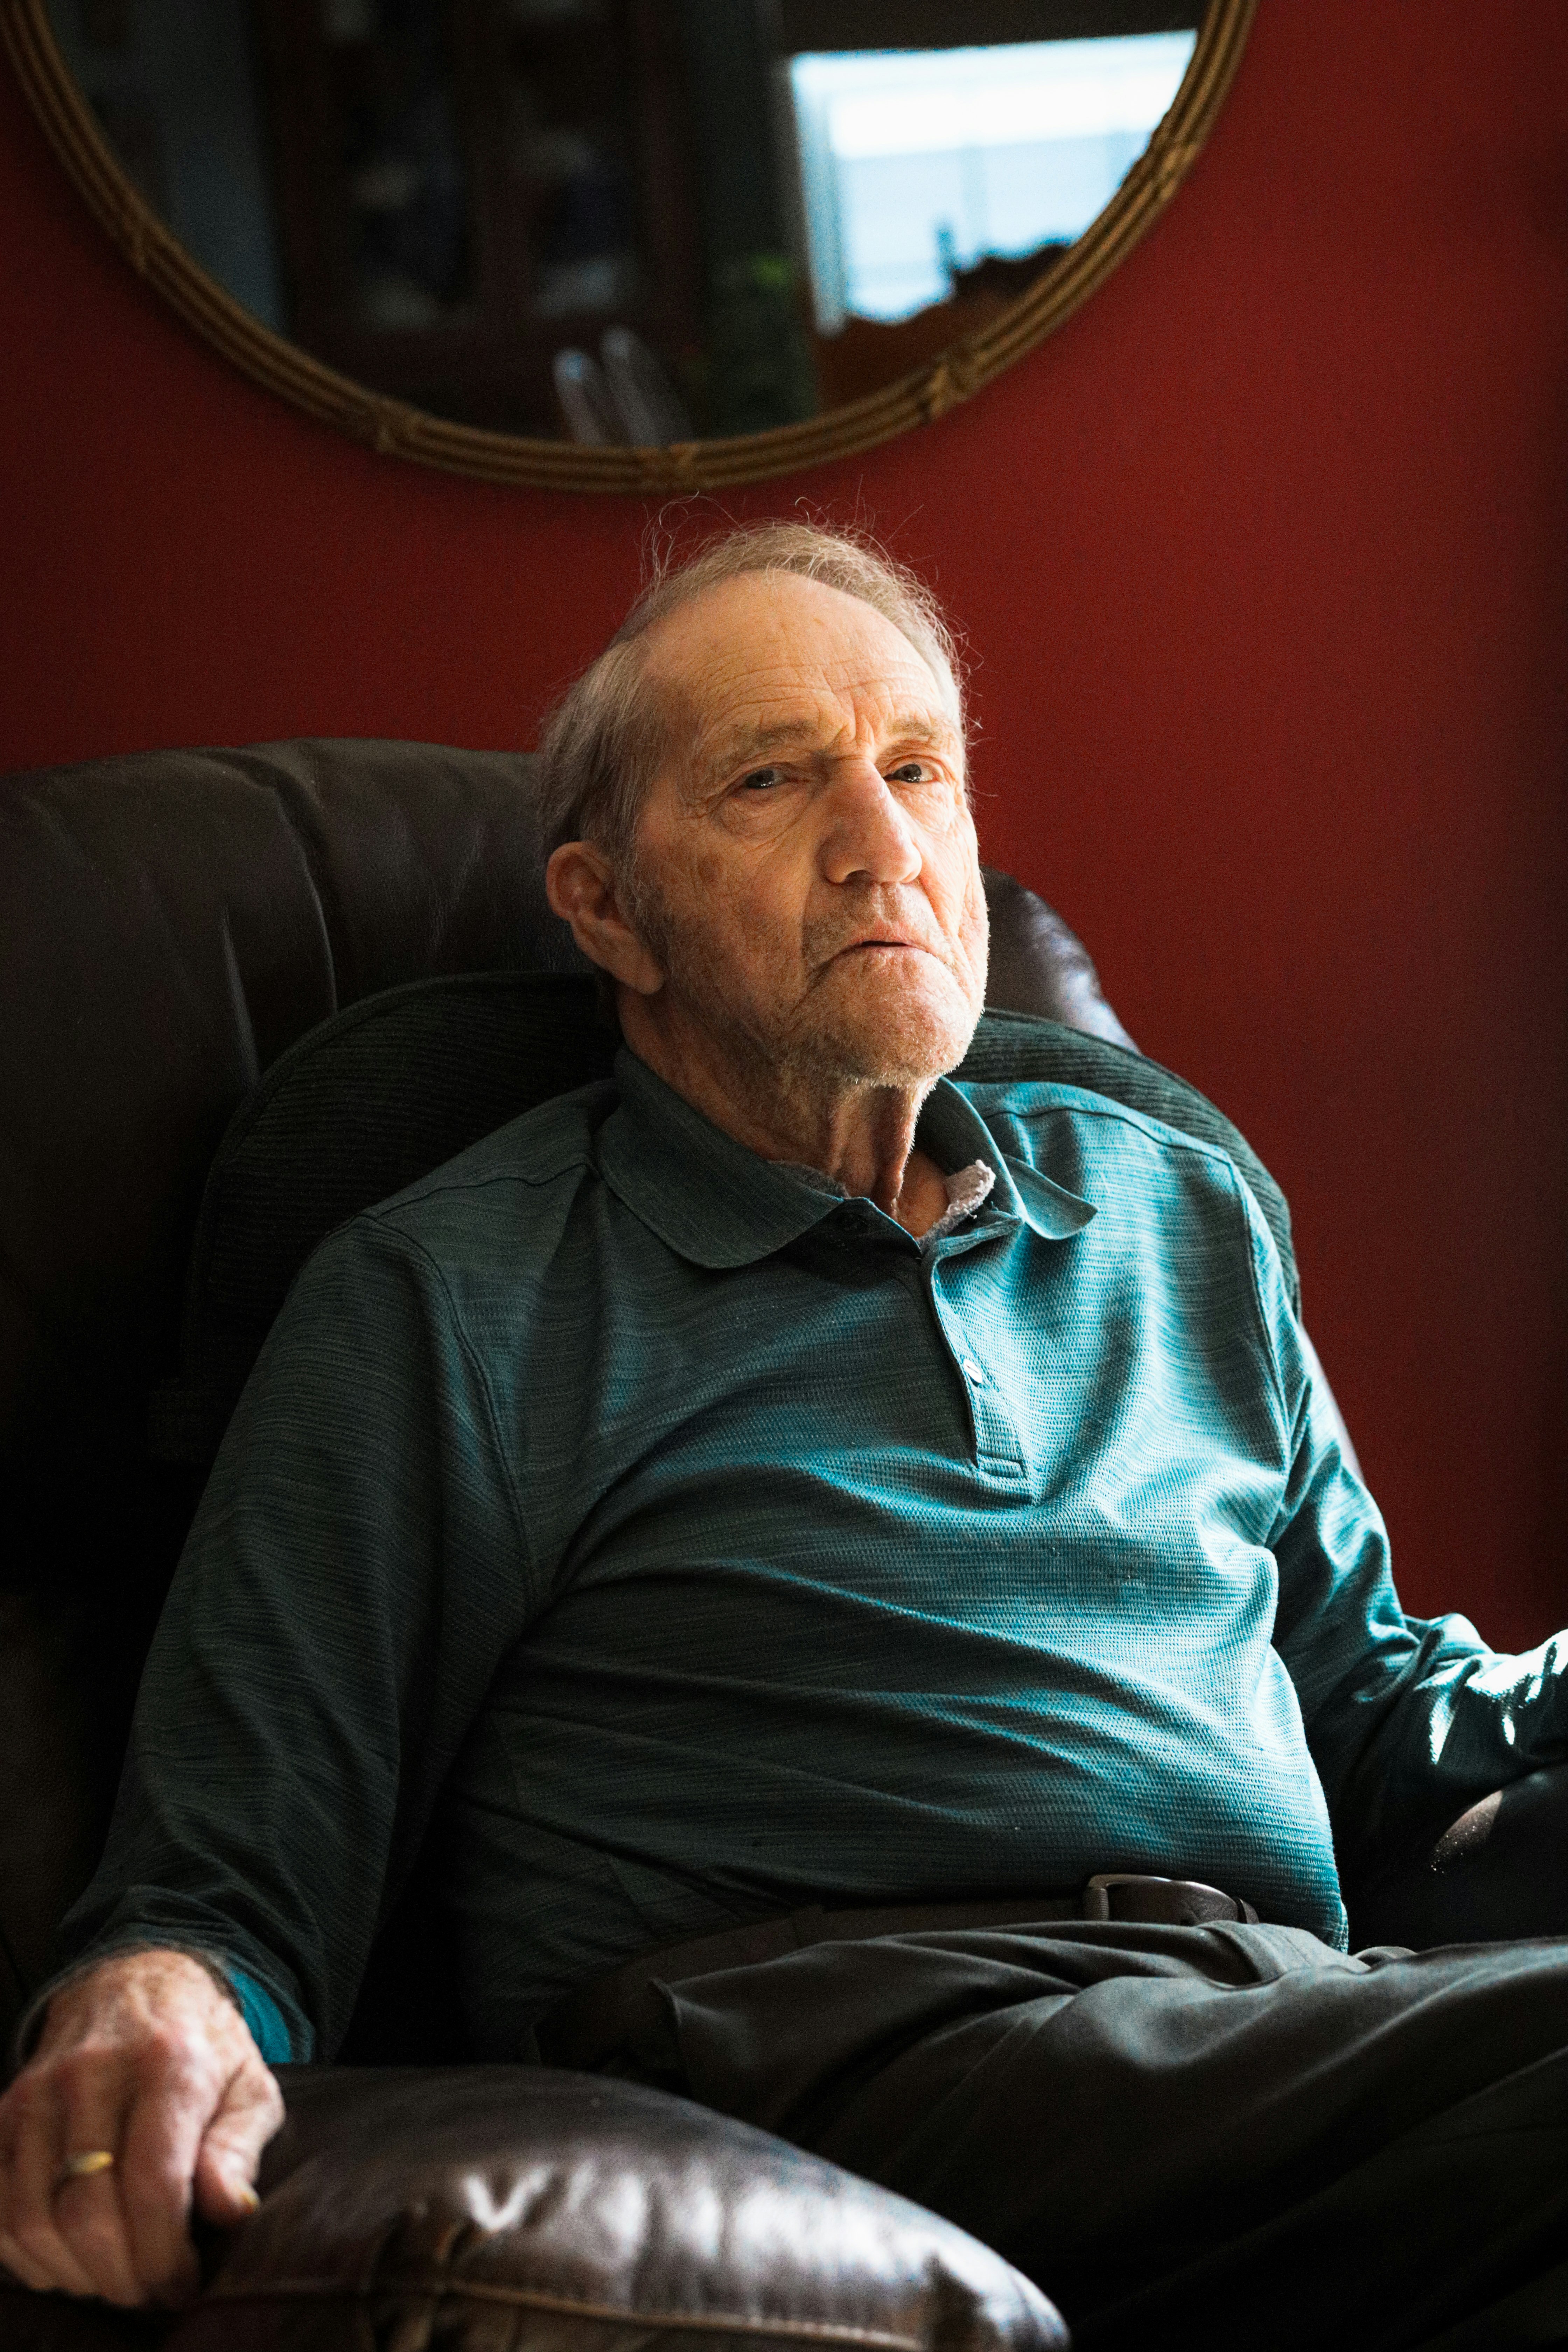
[{"left": 0, "top": 0, "right": 1255, "bottom": 491}]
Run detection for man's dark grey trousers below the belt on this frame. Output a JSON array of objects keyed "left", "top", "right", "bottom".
[{"left": 625, "top": 1921, "right": 1568, "bottom": 2352}]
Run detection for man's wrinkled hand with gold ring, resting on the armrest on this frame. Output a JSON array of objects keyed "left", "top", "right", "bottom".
[{"left": 0, "top": 1952, "right": 282, "bottom": 2303}]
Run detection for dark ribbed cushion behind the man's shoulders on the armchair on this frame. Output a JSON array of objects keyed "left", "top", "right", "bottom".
[{"left": 153, "top": 974, "right": 1295, "bottom": 1463}]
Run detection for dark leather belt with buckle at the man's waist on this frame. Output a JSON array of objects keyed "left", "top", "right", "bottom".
[{"left": 536, "top": 1870, "right": 1258, "bottom": 2072}]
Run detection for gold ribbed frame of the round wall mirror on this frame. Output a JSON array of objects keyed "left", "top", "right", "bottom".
[{"left": 0, "top": 0, "right": 1258, "bottom": 496}]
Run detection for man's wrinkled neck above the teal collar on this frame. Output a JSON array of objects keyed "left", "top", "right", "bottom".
[{"left": 621, "top": 990, "right": 947, "bottom": 1235}]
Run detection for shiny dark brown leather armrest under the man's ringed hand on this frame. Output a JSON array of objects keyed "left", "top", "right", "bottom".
[{"left": 0, "top": 2067, "right": 1067, "bottom": 2352}]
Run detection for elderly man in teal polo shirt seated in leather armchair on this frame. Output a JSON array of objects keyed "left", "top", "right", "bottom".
[{"left": 0, "top": 527, "right": 1568, "bottom": 2347}]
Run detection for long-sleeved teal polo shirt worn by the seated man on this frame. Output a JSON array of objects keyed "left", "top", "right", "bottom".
[{"left": 66, "top": 1051, "right": 1563, "bottom": 2058}]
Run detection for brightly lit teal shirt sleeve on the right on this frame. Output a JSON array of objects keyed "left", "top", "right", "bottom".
[{"left": 1251, "top": 1185, "right": 1568, "bottom": 1868}]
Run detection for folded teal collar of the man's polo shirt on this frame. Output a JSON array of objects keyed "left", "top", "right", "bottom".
[{"left": 597, "top": 1046, "right": 1096, "bottom": 1270}]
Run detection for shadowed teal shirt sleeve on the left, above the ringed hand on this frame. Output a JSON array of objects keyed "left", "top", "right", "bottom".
[{"left": 49, "top": 1216, "right": 531, "bottom": 2060}]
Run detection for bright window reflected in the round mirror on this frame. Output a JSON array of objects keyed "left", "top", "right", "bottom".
[{"left": 788, "top": 33, "right": 1197, "bottom": 334}]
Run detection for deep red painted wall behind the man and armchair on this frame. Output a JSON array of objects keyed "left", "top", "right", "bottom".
[{"left": 0, "top": 0, "right": 1568, "bottom": 1642}]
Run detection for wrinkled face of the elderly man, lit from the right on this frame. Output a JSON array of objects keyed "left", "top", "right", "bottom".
[{"left": 635, "top": 574, "right": 987, "bottom": 1084}]
